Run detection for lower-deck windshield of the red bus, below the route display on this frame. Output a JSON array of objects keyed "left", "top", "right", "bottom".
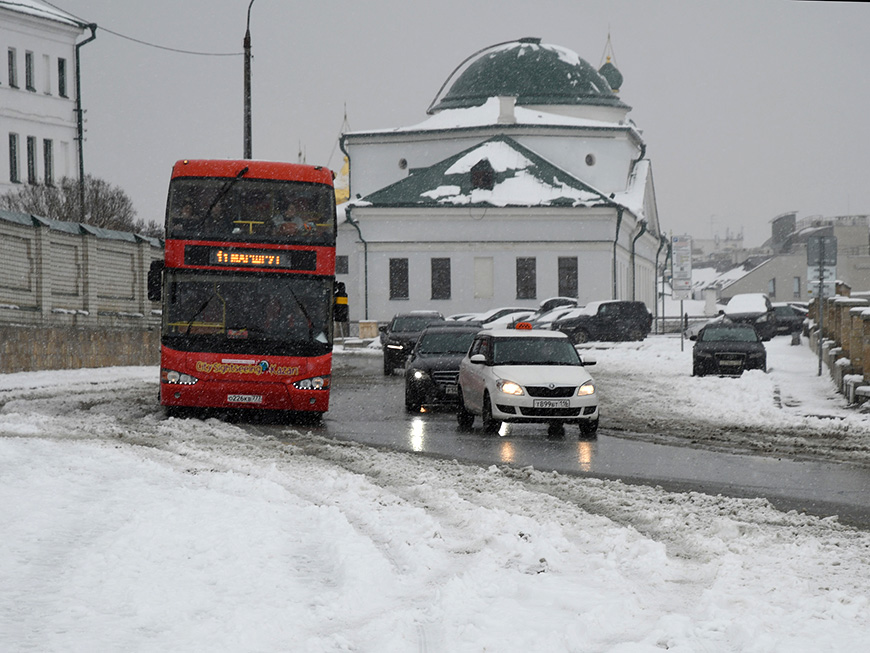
[{"left": 163, "top": 270, "right": 333, "bottom": 356}]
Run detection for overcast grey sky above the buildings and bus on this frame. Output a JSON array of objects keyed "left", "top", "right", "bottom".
[{"left": 54, "top": 0, "right": 870, "bottom": 245}]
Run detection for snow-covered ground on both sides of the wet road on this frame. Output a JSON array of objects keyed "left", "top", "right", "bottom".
[{"left": 0, "top": 337, "right": 870, "bottom": 653}]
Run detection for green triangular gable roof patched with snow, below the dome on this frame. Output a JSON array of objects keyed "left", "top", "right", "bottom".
[{"left": 359, "top": 136, "right": 615, "bottom": 207}]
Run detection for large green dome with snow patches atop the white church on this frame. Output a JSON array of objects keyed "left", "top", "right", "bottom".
[{"left": 429, "top": 38, "right": 629, "bottom": 113}]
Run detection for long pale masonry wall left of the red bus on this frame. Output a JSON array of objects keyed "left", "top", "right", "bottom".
[{"left": 0, "top": 211, "right": 163, "bottom": 373}]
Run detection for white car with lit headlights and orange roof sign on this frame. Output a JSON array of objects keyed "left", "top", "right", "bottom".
[{"left": 457, "top": 329, "right": 598, "bottom": 437}]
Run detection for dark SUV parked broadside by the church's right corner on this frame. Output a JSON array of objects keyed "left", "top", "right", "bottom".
[{"left": 553, "top": 299, "right": 652, "bottom": 344}]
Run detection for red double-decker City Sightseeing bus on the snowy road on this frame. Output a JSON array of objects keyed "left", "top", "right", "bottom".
[{"left": 149, "top": 160, "right": 347, "bottom": 418}]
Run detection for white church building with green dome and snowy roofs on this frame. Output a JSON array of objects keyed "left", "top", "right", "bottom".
[{"left": 336, "top": 38, "right": 667, "bottom": 321}]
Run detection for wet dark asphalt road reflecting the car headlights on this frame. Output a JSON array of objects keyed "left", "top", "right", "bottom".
[{"left": 315, "top": 354, "right": 870, "bottom": 528}]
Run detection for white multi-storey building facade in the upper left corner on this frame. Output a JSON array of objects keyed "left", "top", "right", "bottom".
[{"left": 0, "top": 0, "right": 83, "bottom": 194}]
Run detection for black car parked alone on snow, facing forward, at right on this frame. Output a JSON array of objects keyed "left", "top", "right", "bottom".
[{"left": 692, "top": 321, "right": 767, "bottom": 376}]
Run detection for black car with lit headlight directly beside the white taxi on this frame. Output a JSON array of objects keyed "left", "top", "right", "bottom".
[{"left": 405, "top": 322, "right": 480, "bottom": 412}]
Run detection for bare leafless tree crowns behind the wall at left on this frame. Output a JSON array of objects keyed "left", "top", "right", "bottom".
[{"left": 0, "top": 175, "right": 163, "bottom": 237}]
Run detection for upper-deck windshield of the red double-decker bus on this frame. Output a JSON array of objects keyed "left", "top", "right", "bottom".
[{"left": 166, "top": 177, "right": 335, "bottom": 245}]
